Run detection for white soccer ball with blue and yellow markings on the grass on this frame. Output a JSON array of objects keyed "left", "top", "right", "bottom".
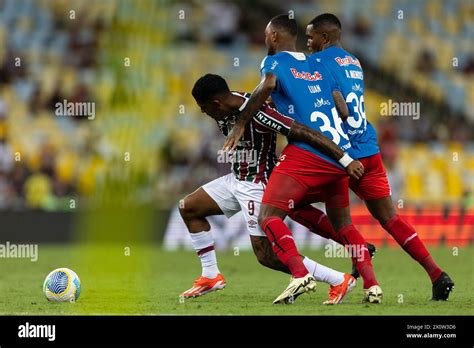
[{"left": 43, "top": 268, "right": 81, "bottom": 302}]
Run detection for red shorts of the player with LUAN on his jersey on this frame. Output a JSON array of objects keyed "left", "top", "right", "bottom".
[{"left": 262, "top": 145, "right": 349, "bottom": 213}]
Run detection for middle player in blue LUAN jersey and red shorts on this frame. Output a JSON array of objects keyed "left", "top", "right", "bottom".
[{"left": 224, "top": 15, "right": 383, "bottom": 303}]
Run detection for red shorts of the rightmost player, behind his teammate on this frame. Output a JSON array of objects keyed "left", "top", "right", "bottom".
[{"left": 349, "top": 153, "right": 391, "bottom": 201}]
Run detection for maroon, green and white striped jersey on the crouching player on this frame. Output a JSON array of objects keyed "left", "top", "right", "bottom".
[{"left": 217, "top": 92, "right": 294, "bottom": 184}]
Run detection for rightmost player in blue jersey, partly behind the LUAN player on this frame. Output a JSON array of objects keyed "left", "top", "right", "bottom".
[{"left": 306, "top": 13, "right": 454, "bottom": 300}]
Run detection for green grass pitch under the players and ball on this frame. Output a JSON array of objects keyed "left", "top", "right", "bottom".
[{"left": 0, "top": 245, "right": 474, "bottom": 315}]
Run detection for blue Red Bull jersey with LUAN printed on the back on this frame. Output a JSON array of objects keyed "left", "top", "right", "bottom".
[{"left": 260, "top": 51, "right": 352, "bottom": 166}]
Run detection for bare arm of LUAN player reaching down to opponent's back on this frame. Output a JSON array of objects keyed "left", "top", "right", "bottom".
[{"left": 223, "top": 73, "right": 277, "bottom": 151}]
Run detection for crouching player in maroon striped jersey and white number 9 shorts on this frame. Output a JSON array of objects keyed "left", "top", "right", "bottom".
[{"left": 179, "top": 74, "right": 363, "bottom": 304}]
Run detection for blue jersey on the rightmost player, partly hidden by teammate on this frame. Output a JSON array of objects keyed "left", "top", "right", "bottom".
[{"left": 309, "top": 46, "right": 380, "bottom": 158}]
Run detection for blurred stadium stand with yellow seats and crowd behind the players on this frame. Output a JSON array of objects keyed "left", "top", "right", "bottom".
[{"left": 0, "top": 0, "right": 474, "bottom": 218}]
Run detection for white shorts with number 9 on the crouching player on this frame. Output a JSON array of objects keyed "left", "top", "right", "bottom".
[{"left": 202, "top": 173, "right": 266, "bottom": 237}]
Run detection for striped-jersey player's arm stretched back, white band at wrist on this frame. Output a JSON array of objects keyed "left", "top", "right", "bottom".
[{"left": 254, "top": 104, "right": 364, "bottom": 180}]
